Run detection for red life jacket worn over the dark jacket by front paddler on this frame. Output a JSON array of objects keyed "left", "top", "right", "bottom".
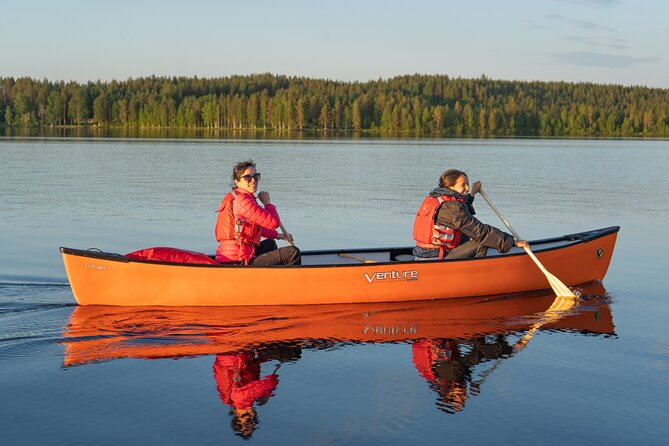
[{"left": 413, "top": 195, "right": 464, "bottom": 259}]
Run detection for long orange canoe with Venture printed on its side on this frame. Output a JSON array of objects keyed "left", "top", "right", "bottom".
[{"left": 60, "top": 226, "right": 620, "bottom": 306}]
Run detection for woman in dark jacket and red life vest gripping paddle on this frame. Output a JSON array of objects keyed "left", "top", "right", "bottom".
[{"left": 413, "top": 169, "right": 528, "bottom": 260}]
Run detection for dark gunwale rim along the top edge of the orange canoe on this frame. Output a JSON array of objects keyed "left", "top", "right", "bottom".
[{"left": 60, "top": 226, "right": 620, "bottom": 269}]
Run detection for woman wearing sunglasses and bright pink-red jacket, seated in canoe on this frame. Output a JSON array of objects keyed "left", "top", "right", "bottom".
[{"left": 215, "top": 160, "right": 301, "bottom": 265}]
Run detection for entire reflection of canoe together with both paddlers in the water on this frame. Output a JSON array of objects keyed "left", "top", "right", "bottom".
[{"left": 62, "top": 283, "right": 615, "bottom": 438}]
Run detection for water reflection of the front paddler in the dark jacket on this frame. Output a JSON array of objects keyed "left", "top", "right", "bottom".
[{"left": 412, "top": 335, "right": 513, "bottom": 413}]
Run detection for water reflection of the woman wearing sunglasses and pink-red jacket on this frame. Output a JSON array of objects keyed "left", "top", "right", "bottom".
[{"left": 214, "top": 346, "right": 301, "bottom": 439}]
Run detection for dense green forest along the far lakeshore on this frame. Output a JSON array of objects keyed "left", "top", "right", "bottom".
[{"left": 0, "top": 74, "right": 669, "bottom": 137}]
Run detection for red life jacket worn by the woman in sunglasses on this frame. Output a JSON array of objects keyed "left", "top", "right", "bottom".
[{"left": 216, "top": 191, "right": 262, "bottom": 263}]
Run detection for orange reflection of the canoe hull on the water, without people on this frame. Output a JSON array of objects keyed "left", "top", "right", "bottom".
[{"left": 62, "top": 283, "right": 614, "bottom": 367}]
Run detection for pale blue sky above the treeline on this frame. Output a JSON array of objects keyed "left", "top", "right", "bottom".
[{"left": 0, "top": 0, "right": 669, "bottom": 88}]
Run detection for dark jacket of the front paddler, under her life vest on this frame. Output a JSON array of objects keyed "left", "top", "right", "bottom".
[{"left": 430, "top": 188, "right": 515, "bottom": 252}]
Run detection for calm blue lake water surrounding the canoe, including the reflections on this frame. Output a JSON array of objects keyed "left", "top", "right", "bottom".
[{"left": 0, "top": 138, "right": 669, "bottom": 445}]
